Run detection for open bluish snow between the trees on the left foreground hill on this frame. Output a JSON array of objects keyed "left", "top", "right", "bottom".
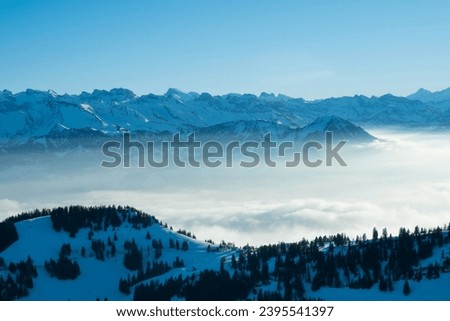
[{"left": 0, "top": 210, "right": 234, "bottom": 300}]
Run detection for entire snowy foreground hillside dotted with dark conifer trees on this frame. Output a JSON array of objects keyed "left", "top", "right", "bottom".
[{"left": 0, "top": 206, "right": 450, "bottom": 300}]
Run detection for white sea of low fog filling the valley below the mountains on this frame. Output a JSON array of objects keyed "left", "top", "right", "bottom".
[{"left": 0, "top": 129, "right": 450, "bottom": 245}]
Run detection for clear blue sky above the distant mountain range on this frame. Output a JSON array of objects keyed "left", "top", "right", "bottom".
[{"left": 0, "top": 0, "right": 450, "bottom": 99}]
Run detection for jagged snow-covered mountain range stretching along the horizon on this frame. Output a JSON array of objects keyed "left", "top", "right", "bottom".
[{"left": 0, "top": 89, "right": 450, "bottom": 149}]
